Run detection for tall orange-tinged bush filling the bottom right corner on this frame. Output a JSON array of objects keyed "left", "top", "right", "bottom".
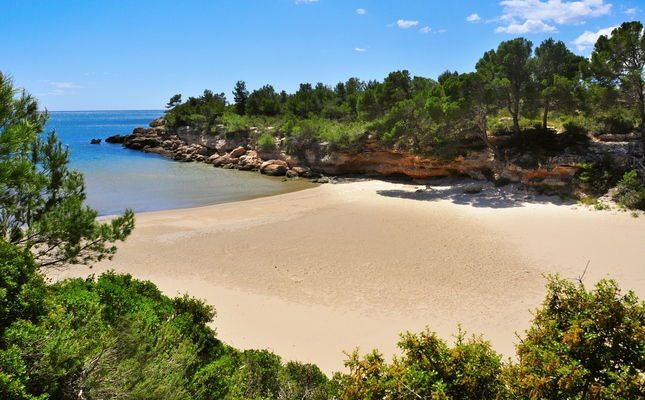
[{"left": 505, "top": 276, "right": 645, "bottom": 399}]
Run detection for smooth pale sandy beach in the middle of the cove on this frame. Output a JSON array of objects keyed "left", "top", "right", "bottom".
[{"left": 50, "top": 181, "right": 645, "bottom": 374}]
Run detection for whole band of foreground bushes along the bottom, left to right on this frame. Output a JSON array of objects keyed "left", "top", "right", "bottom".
[{"left": 0, "top": 242, "right": 645, "bottom": 400}]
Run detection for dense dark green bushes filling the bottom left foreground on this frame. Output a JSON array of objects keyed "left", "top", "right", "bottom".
[{"left": 0, "top": 242, "right": 334, "bottom": 399}]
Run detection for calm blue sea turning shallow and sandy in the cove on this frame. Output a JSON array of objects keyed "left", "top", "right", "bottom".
[{"left": 46, "top": 110, "right": 312, "bottom": 215}]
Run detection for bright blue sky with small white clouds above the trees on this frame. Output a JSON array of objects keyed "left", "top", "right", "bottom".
[{"left": 0, "top": 0, "right": 645, "bottom": 111}]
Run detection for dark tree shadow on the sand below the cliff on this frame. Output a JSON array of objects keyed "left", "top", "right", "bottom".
[{"left": 376, "top": 180, "right": 573, "bottom": 208}]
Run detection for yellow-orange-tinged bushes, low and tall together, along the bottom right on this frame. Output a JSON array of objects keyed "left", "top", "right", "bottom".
[{"left": 334, "top": 276, "right": 645, "bottom": 400}]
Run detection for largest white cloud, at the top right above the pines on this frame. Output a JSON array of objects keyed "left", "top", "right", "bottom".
[{"left": 500, "top": 0, "right": 612, "bottom": 25}]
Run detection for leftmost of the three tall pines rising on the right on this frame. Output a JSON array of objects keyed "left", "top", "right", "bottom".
[{"left": 475, "top": 38, "right": 533, "bottom": 135}]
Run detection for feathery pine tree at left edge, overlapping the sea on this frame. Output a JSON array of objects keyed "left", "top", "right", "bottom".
[{"left": 0, "top": 73, "right": 134, "bottom": 267}]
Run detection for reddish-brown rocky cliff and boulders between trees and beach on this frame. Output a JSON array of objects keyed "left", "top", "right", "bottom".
[{"left": 113, "top": 120, "right": 643, "bottom": 192}]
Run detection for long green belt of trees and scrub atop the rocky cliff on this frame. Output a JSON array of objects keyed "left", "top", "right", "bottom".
[{"left": 166, "top": 21, "right": 645, "bottom": 161}]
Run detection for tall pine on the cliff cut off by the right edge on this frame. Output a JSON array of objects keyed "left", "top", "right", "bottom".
[{"left": 591, "top": 21, "right": 645, "bottom": 145}]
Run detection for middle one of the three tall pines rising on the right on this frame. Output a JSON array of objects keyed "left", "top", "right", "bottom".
[{"left": 533, "top": 39, "right": 587, "bottom": 129}]
